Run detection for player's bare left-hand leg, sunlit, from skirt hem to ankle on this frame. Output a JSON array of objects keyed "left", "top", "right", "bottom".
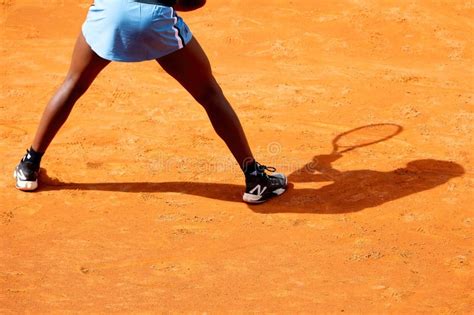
[{"left": 32, "top": 33, "right": 110, "bottom": 153}]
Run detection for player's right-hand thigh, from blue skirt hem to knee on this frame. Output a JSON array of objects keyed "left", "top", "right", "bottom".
[{"left": 157, "top": 37, "right": 217, "bottom": 97}]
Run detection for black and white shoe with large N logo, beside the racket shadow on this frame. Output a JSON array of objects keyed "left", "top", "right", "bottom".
[{"left": 243, "top": 163, "right": 288, "bottom": 203}]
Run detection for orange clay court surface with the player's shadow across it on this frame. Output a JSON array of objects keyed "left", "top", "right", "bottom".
[{"left": 0, "top": 0, "right": 474, "bottom": 314}]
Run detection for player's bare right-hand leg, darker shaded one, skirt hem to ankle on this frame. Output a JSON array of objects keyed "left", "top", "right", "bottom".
[{"left": 157, "top": 38, "right": 253, "bottom": 168}]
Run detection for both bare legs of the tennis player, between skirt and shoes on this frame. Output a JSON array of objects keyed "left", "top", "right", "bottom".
[{"left": 32, "top": 33, "right": 253, "bottom": 167}]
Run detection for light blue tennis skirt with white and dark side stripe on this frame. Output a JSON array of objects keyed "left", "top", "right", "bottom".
[{"left": 82, "top": 0, "right": 192, "bottom": 62}]
